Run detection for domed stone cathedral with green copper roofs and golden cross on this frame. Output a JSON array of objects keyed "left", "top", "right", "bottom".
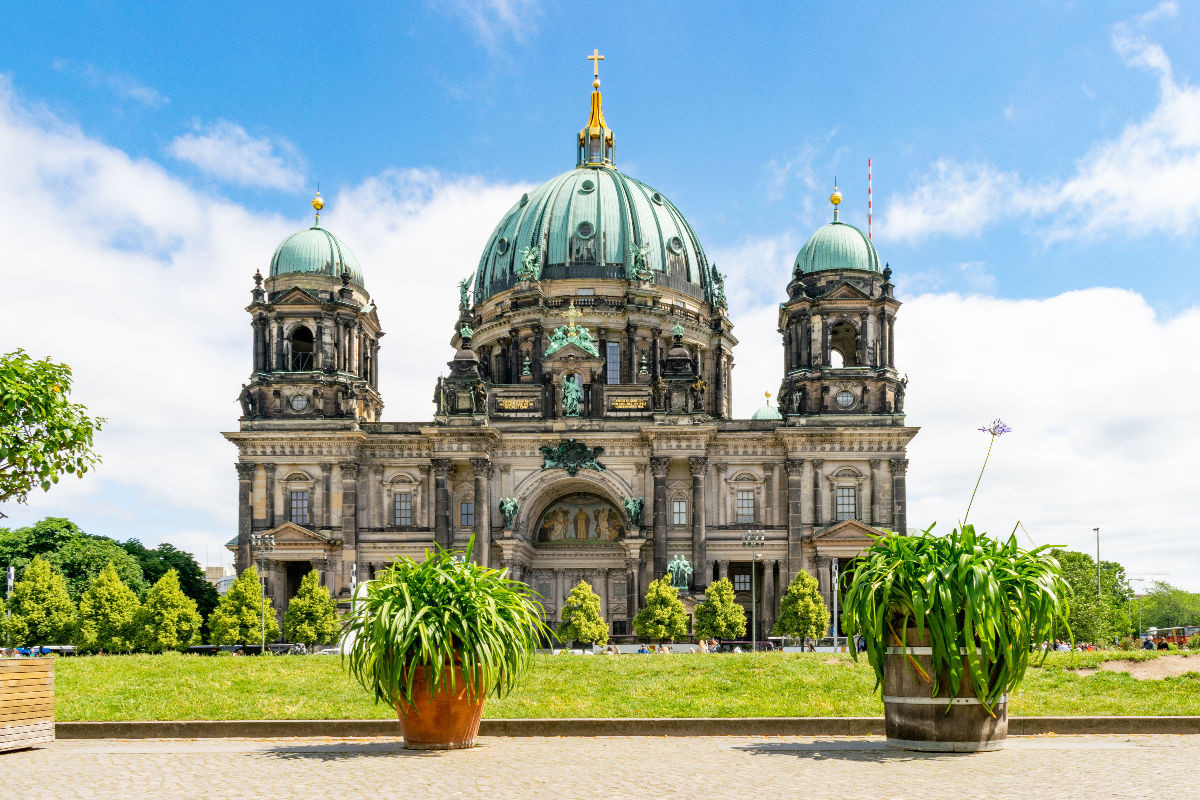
[{"left": 224, "top": 54, "right": 917, "bottom": 637}]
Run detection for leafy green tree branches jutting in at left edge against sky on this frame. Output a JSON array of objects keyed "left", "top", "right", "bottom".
[{"left": 0, "top": 349, "right": 104, "bottom": 503}]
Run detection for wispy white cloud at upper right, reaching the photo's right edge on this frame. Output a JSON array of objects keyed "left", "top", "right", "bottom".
[{"left": 881, "top": 16, "right": 1200, "bottom": 241}]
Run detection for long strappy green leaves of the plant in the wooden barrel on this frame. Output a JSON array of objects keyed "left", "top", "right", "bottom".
[{"left": 841, "top": 525, "right": 1070, "bottom": 712}]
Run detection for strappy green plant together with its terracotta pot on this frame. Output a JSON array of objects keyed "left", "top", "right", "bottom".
[{"left": 342, "top": 539, "right": 550, "bottom": 750}]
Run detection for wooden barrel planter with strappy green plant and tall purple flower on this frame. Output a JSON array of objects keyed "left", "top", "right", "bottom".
[{"left": 842, "top": 420, "right": 1070, "bottom": 751}]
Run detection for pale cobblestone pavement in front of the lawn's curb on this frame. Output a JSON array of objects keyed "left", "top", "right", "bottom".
[{"left": 0, "top": 735, "right": 1200, "bottom": 800}]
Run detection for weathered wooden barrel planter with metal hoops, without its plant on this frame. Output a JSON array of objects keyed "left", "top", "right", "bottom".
[{"left": 883, "top": 630, "right": 1008, "bottom": 753}]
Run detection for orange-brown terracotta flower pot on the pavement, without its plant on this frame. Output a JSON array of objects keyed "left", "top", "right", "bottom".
[{"left": 396, "top": 664, "right": 487, "bottom": 750}]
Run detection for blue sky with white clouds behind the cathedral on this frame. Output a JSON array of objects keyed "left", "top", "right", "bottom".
[{"left": 0, "top": 0, "right": 1200, "bottom": 589}]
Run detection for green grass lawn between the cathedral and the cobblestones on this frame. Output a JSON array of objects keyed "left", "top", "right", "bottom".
[{"left": 55, "top": 652, "right": 1200, "bottom": 721}]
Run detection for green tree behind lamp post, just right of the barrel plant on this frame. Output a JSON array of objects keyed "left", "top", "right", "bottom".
[{"left": 1050, "top": 549, "right": 1134, "bottom": 644}]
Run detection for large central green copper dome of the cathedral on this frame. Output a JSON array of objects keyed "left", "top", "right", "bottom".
[{"left": 475, "top": 164, "right": 712, "bottom": 302}]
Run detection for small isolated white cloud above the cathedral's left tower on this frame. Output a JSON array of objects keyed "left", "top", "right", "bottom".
[{"left": 167, "top": 120, "right": 305, "bottom": 191}]
